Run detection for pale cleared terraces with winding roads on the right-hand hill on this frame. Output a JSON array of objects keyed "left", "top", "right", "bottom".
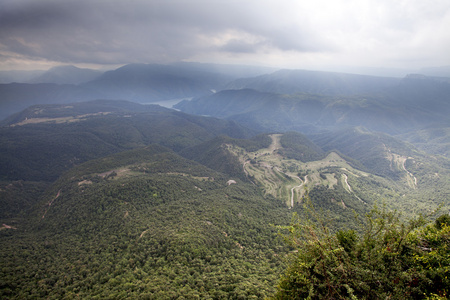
[{"left": 222, "top": 134, "right": 442, "bottom": 216}]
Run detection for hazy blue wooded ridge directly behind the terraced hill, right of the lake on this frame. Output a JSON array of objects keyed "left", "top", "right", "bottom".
[{"left": 175, "top": 89, "right": 442, "bottom": 134}]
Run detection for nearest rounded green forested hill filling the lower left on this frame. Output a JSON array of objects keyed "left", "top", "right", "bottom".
[{"left": 0, "top": 146, "right": 289, "bottom": 299}]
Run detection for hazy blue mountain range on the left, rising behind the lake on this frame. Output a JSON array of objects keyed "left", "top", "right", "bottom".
[{"left": 0, "top": 63, "right": 273, "bottom": 119}]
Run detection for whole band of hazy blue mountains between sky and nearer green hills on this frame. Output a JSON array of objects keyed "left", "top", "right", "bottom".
[{"left": 0, "top": 63, "right": 450, "bottom": 155}]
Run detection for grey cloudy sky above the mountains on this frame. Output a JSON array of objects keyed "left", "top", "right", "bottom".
[{"left": 0, "top": 0, "right": 450, "bottom": 70}]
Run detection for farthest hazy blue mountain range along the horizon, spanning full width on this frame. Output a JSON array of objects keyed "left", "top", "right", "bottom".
[{"left": 0, "top": 63, "right": 448, "bottom": 118}]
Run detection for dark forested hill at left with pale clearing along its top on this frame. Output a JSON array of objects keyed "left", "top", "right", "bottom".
[{"left": 0, "top": 101, "right": 254, "bottom": 181}]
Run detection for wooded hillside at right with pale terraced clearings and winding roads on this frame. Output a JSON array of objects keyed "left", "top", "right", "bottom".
[{"left": 181, "top": 129, "right": 450, "bottom": 220}]
